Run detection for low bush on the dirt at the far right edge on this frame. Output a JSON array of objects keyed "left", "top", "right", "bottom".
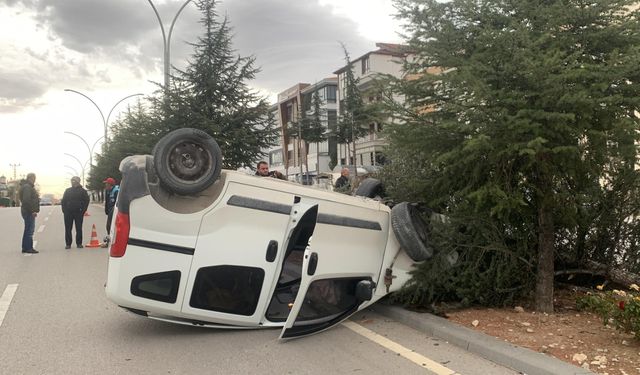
[{"left": 576, "top": 284, "right": 640, "bottom": 340}]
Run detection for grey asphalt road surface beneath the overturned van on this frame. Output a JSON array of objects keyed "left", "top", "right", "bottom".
[{"left": 0, "top": 205, "right": 517, "bottom": 375}]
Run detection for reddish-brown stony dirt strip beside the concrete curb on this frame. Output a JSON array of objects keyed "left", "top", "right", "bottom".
[{"left": 446, "top": 291, "right": 640, "bottom": 375}]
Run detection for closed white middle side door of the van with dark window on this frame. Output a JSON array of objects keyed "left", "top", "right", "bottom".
[{"left": 182, "top": 182, "right": 316, "bottom": 327}]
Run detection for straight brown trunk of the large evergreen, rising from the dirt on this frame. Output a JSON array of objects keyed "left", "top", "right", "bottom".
[{"left": 536, "top": 203, "right": 554, "bottom": 313}]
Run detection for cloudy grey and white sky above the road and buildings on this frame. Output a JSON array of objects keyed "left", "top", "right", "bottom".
[{"left": 0, "top": 0, "right": 402, "bottom": 195}]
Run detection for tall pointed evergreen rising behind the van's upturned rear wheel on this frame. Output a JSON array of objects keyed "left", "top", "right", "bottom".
[{"left": 163, "top": 0, "right": 277, "bottom": 169}]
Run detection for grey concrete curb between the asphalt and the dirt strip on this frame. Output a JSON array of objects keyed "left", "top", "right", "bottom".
[{"left": 369, "top": 304, "right": 594, "bottom": 375}]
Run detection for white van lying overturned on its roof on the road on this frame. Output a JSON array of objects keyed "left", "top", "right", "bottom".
[{"left": 106, "top": 128, "right": 432, "bottom": 338}]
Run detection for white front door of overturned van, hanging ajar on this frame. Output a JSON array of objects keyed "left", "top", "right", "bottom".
[{"left": 280, "top": 201, "right": 389, "bottom": 339}]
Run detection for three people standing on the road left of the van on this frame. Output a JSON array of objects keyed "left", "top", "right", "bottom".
[{"left": 18, "top": 173, "right": 120, "bottom": 254}]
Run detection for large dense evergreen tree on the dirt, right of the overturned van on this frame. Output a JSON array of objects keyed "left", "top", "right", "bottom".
[{"left": 386, "top": 0, "right": 640, "bottom": 312}]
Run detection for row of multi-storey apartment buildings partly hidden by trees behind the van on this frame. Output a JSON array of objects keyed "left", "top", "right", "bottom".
[{"left": 268, "top": 43, "right": 409, "bottom": 182}]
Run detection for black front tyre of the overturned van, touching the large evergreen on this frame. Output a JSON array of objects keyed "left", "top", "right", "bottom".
[{"left": 391, "top": 202, "right": 433, "bottom": 262}]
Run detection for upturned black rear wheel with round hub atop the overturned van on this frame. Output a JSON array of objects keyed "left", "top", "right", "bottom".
[{"left": 153, "top": 128, "right": 222, "bottom": 195}]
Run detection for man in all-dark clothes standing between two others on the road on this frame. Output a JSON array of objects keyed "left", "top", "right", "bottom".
[{"left": 61, "top": 176, "right": 89, "bottom": 250}]
